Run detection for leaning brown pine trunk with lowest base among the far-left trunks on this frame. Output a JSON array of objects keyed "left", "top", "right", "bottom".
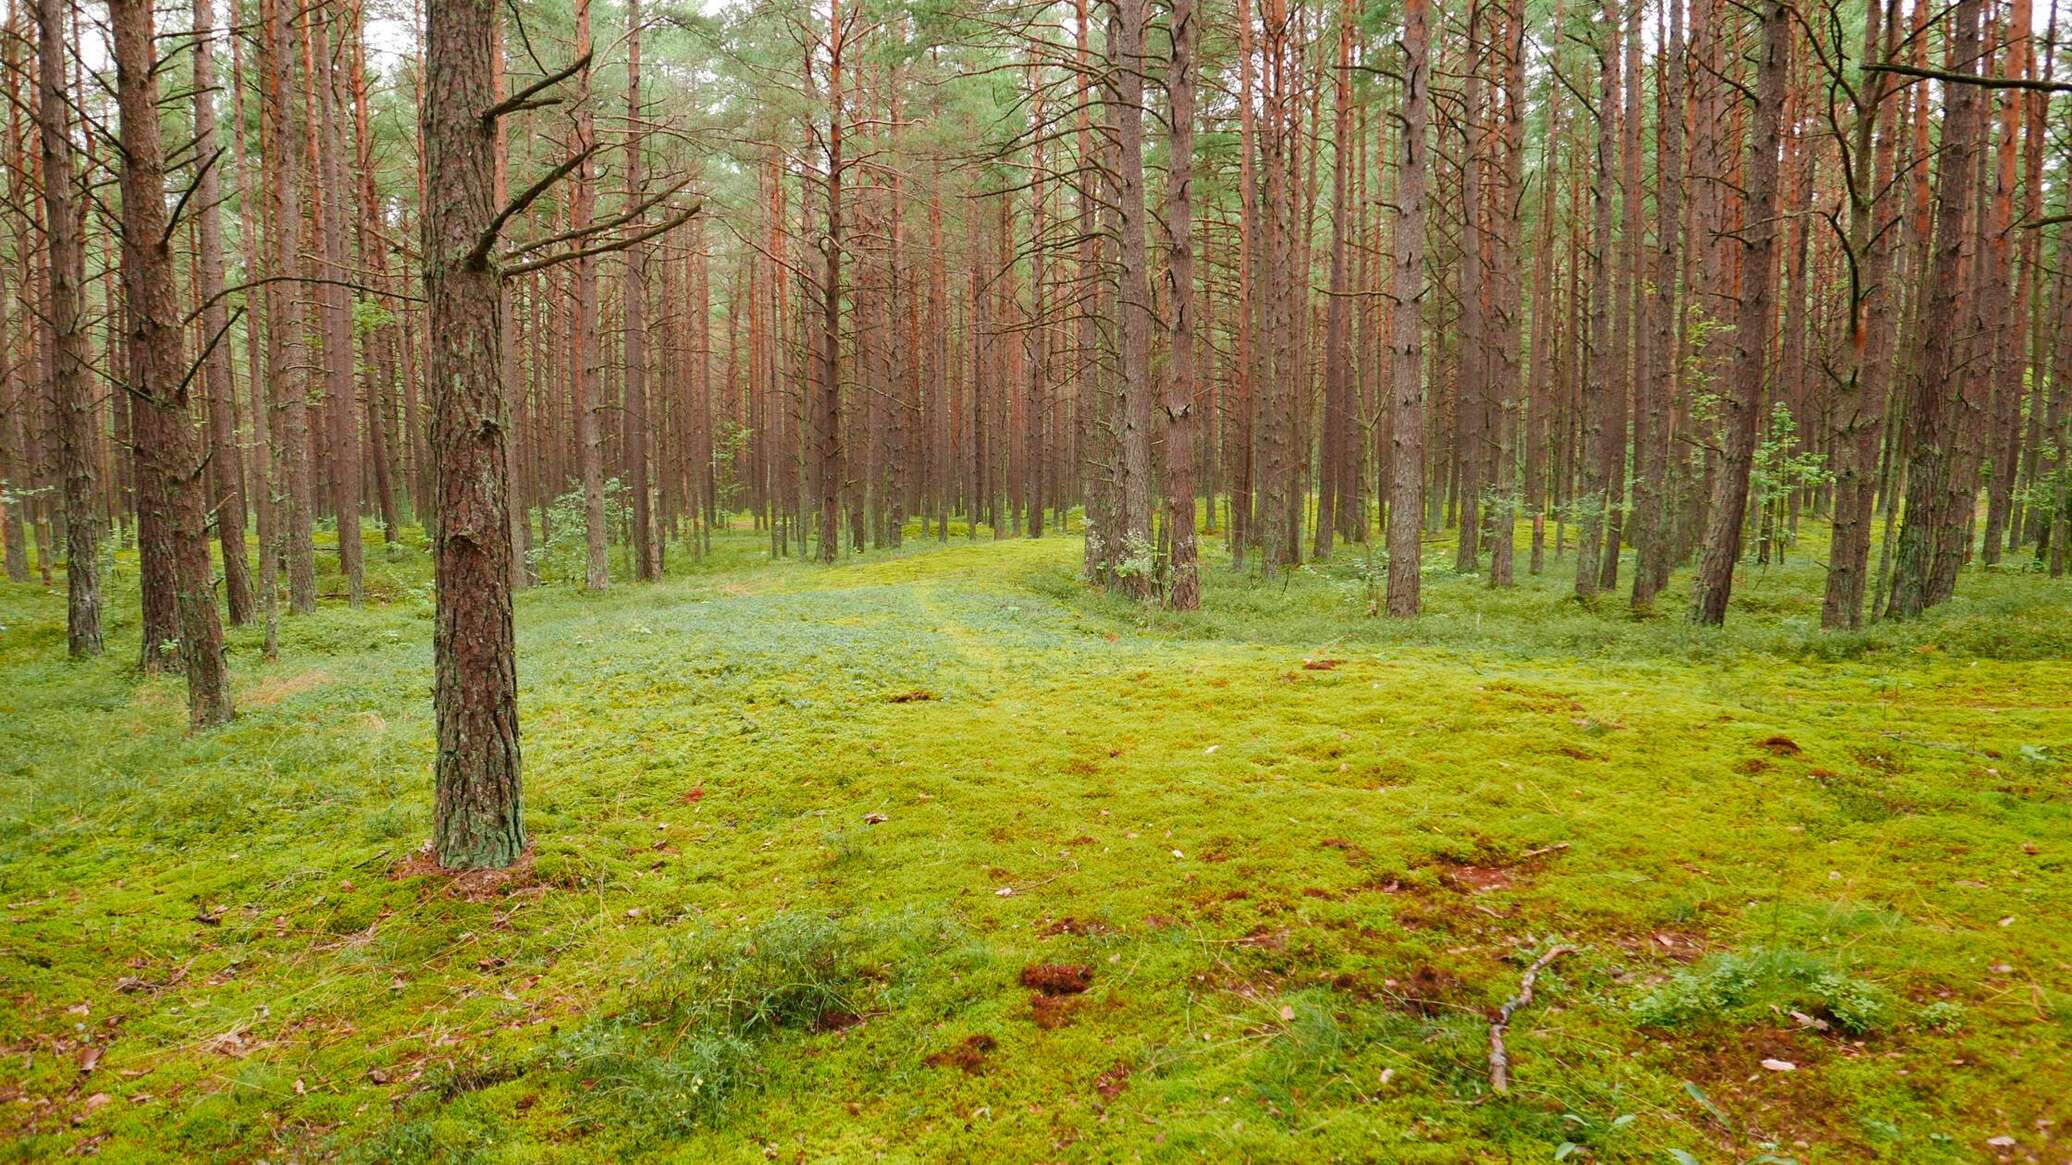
[{"left": 110, "top": 0, "right": 230, "bottom": 728}]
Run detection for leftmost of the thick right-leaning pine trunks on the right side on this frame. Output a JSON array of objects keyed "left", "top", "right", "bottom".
[{"left": 1691, "top": 0, "right": 1792, "bottom": 626}]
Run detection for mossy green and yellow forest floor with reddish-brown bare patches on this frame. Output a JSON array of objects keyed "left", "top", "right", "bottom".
[{"left": 0, "top": 518, "right": 2072, "bottom": 1165}]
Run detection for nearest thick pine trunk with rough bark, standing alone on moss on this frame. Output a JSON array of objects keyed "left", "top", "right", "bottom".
[{"left": 423, "top": 0, "right": 524, "bottom": 869}]
